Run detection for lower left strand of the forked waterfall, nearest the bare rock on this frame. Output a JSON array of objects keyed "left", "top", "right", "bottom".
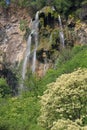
[{"left": 22, "top": 34, "right": 31, "bottom": 80}]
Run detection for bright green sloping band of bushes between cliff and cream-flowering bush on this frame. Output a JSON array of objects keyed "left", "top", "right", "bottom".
[{"left": 38, "top": 46, "right": 87, "bottom": 97}]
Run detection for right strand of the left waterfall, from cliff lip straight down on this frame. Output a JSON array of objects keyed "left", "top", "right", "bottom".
[{"left": 32, "top": 12, "right": 39, "bottom": 73}]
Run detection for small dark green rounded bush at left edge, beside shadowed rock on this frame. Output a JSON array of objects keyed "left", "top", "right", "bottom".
[{"left": 0, "top": 78, "right": 11, "bottom": 97}]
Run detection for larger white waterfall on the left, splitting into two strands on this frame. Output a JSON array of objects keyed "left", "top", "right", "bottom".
[{"left": 22, "top": 12, "right": 39, "bottom": 80}]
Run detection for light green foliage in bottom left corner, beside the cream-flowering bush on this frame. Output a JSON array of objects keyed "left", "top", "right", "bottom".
[{"left": 0, "top": 94, "right": 43, "bottom": 130}]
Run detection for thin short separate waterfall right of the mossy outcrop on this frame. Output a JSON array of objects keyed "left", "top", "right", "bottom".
[{"left": 58, "top": 15, "right": 65, "bottom": 47}]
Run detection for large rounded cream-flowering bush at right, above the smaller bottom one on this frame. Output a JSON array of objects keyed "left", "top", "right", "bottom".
[{"left": 39, "top": 69, "right": 87, "bottom": 129}]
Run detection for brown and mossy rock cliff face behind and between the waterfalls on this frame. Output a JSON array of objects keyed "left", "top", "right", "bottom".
[{"left": 0, "top": 7, "right": 87, "bottom": 77}]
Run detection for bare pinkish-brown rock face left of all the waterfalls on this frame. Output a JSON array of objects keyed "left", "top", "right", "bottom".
[{"left": 0, "top": 7, "right": 30, "bottom": 64}]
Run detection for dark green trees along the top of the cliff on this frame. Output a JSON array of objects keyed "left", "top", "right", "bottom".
[{"left": 0, "top": 0, "right": 87, "bottom": 15}]
